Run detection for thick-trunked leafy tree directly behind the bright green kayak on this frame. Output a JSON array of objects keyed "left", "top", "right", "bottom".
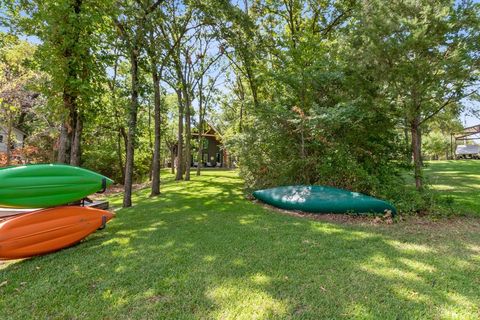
[{"left": 7, "top": 0, "right": 104, "bottom": 165}]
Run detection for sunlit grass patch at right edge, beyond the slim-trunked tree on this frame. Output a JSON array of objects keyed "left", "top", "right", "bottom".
[{"left": 425, "top": 160, "right": 480, "bottom": 216}]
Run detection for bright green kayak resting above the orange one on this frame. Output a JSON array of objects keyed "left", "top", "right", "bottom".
[{"left": 0, "top": 164, "right": 113, "bottom": 208}]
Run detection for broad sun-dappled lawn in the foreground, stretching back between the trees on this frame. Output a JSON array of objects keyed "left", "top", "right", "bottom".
[{"left": 0, "top": 171, "right": 480, "bottom": 319}]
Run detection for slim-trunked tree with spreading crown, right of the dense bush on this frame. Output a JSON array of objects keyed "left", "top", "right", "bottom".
[{"left": 356, "top": 1, "right": 480, "bottom": 190}]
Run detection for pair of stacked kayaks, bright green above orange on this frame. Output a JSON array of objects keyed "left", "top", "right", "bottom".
[{"left": 0, "top": 164, "right": 113, "bottom": 259}]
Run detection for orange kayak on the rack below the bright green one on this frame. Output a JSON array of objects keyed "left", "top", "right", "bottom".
[{"left": 0, "top": 206, "right": 114, "bottom": 259}]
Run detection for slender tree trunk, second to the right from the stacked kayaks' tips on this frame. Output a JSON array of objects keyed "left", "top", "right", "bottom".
[{"left": 150, "top": 63, "right": 162, "bottom": 197}]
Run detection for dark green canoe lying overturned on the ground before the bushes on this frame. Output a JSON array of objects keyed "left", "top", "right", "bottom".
[{"left": 253, "top": 186, "right": 397, "bottom": 214}]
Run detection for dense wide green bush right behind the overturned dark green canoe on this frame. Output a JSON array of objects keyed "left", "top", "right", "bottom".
[{"left": 227, "top": 101, "right": 434, "bottom": 213}]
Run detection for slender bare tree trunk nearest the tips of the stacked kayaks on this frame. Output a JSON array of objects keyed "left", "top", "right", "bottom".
[{"left": 123, "top": 43, "right": 139, "bottom": 208}]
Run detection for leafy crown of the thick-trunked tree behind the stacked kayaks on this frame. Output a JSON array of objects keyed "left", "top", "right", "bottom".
[{"left": 7, "top": 0, "right": 109, "bottom": 113}]
